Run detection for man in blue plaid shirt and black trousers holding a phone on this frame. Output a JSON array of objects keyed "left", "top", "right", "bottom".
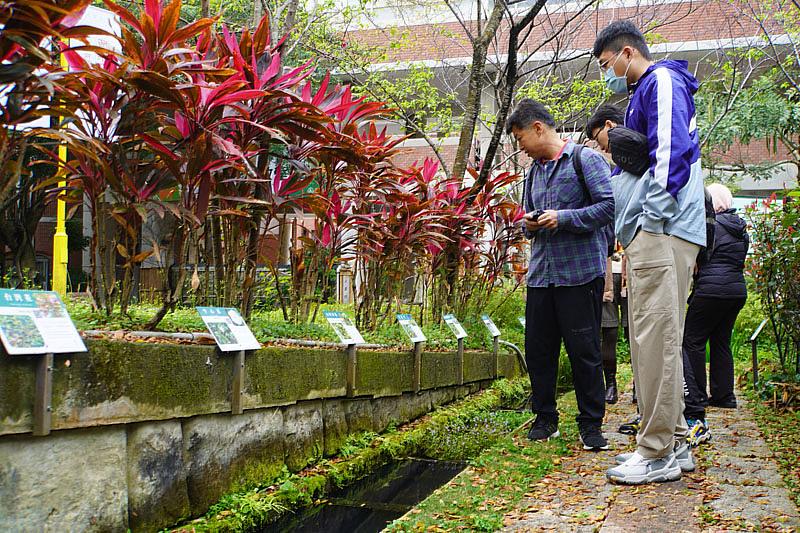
[{"left": 506, "top": 98, "right": 614, "bottom": 450}]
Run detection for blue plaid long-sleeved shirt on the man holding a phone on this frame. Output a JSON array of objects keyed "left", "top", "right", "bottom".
[{"left": 523, "top": 141, "right": 614, "bottom": 287}]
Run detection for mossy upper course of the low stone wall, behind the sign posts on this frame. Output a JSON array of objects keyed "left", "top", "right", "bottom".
[{"left": 0, "top": 341, "right": 518, "bottom": 435}]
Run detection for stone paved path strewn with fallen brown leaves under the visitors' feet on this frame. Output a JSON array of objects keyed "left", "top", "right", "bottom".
[{"left": 504, "top": 384, "right": 800, "bottom": 533}]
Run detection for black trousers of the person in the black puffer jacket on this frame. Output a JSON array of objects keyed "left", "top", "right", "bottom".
[{"left": 683, "top": 296, "right": 747, "bottom": 418}]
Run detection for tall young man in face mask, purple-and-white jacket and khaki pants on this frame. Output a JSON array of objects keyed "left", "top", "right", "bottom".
[{"left": 593, "top": 20, "right": 706, "bottom": 484}]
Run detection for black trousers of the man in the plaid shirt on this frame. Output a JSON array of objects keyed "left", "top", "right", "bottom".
[{"left": 525, "top": 278, "right": 605, "bottom": 425}]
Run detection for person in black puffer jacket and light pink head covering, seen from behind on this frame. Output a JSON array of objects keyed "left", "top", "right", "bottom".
[{"left": 683, "top": 183, "right": 750, "bottom": 445}]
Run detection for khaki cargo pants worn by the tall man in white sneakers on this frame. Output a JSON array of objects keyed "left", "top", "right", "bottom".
[{"left": 625, "top": 231, "right": 700, "bottom": 458}]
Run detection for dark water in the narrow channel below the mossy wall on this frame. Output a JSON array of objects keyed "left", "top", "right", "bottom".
[{"left": 270, "top": 459, "right": 465, "bottom": 533}]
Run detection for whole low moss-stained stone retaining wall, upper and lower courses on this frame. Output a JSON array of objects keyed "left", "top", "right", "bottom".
[{"left": 0, "top": 341, "right": 519, "bottom": 531}]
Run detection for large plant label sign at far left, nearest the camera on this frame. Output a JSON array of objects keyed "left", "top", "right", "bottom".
[{"left": 0, "top": 289, "right": 86, "bottom": 355}]
